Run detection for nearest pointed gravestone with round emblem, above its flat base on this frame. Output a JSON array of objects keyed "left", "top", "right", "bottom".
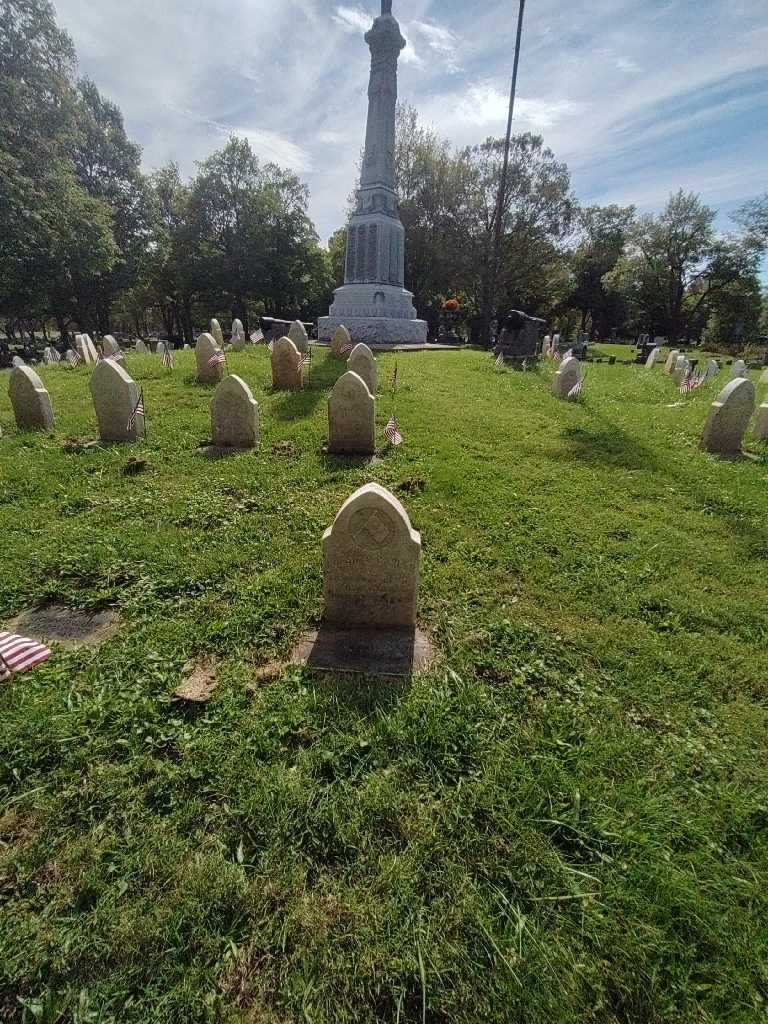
[{"left": 323, "top": 481, "right": 421, "bottom": 629}]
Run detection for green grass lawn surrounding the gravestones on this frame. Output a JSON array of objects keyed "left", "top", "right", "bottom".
[{"left": 0, "top": 348, "right": 768, "bottom": 1024}]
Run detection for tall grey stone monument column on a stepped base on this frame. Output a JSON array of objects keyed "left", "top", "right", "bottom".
[{"left": 317, "top": 0, "right": 427, "bottom": 348}]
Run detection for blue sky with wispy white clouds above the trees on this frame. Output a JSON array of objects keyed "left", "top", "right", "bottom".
[{"left": 54, "top": 0, "right": 768, "bottom": 240}]
